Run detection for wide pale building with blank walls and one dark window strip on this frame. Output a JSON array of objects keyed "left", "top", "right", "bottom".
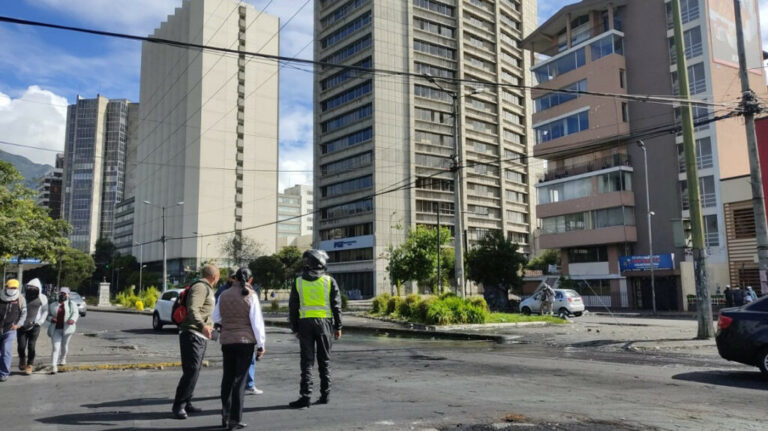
[{"left": 133, "top": 0, "right": 279, "bottom": 278}]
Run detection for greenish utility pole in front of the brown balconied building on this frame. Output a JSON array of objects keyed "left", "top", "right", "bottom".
[{"left": 672, "top": 0, "right": 714, "bottom": 339}]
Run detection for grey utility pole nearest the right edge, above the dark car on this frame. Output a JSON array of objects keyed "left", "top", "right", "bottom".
[{"left": 733, "top": 0, "right": 768, "bottom": 295}]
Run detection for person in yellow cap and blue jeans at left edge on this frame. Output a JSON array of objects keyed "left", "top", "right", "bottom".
[{"left": 0, "top": 278, "right": 27, "bottom": 382}]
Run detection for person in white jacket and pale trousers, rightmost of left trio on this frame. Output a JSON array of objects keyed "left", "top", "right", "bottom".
[{"left": 48, "top": 287, "right": 80, "bottom": 374}]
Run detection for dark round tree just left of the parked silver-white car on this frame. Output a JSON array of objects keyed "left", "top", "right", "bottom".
[{"left": 467, "top": 230, "right": 526, "bottom": 310}]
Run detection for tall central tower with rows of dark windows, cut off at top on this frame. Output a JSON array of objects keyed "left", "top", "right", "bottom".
[{"left": 314, "top": 0, "right": 536, "bottom": 296}]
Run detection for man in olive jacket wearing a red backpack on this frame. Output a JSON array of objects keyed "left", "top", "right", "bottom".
[{"left": 171, "top": 264, "right": 219, "bottom": 419}]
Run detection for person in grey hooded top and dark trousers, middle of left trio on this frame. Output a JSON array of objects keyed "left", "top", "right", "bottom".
[{"left": 16, "top": 278, "right": 48, "bottom": 375}]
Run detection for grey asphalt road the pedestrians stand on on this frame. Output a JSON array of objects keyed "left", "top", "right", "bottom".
[{"left": 0, "top": 312, "right": 768, "bottom": 431}]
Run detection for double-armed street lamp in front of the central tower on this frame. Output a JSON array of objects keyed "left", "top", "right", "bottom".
[{"left": 424, "top": 73, "right": 485, "bottom": 296}]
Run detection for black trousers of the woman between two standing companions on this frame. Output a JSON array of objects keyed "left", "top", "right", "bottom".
[{"left": 221, "top": 343, "right": 255, "bottom": 423}]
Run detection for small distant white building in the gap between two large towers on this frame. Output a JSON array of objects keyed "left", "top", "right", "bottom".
[{"left": 277, "top": 184, "right": 315, "bottom": 248}]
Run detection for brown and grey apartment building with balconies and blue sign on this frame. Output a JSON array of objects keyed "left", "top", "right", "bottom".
[{"left": 524, "top": 0, "right": 765, "bottom": 310}]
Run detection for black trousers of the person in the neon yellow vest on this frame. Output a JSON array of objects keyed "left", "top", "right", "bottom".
[{"left": 299, "top": 319, "right": 333, "bottom": 397}]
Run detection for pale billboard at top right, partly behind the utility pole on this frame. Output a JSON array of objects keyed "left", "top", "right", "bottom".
[{"left": 709, "top": 0, "right": 763, "bottom": 73}]
